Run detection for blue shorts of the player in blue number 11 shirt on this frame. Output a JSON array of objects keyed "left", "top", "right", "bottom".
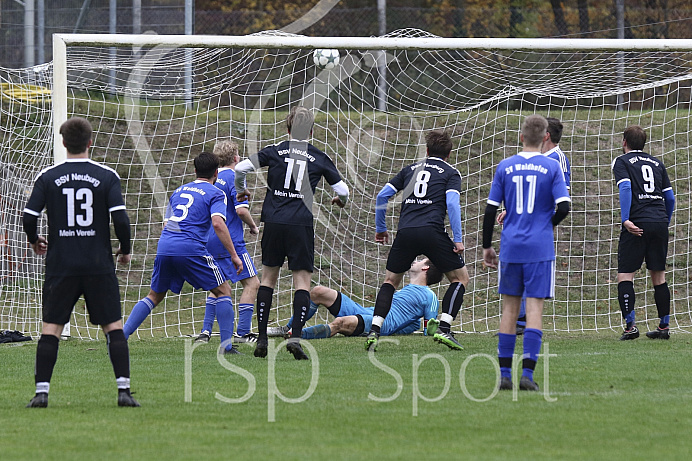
[{"left": 497, "top": 260, "right": 555, "bottom": 299}]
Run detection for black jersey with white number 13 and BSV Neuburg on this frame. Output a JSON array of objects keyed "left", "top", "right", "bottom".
[{"left": 24, "top": 159, "right": 125, "bottom": 275}]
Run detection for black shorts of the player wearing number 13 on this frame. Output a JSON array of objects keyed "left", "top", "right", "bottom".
[{"left": 43, "top": 273, "right": 122, "bottom": 325}]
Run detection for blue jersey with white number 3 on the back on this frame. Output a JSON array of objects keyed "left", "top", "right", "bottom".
[{"left": 156, "top": 180, "right": 227, "bottom": 256}]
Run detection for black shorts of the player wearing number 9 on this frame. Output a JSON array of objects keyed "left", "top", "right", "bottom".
[{"left": 618, "top": 222, "right": 668, "bottom": 273}]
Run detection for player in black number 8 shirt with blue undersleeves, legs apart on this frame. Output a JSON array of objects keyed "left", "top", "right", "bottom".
[{"left": 365, "top": 130, "right": 469, "bottom": 351}]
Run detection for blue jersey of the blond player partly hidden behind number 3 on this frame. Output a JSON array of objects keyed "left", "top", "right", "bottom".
[{"left": 207, "top": 168, "right": 249, "bottom": 259}]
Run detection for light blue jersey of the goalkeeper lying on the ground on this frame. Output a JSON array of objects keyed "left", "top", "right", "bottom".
[{"left": 381, "top": 284, "right": 439, "bottom": 335}]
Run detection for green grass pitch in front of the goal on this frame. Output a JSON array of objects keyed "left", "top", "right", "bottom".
[{"left": 0, "top": 332, "right": 692, "bottom": 460}]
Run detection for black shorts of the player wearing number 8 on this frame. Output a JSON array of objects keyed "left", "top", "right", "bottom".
[{"left": 387, "top": 227, "right": 465, "bottom": 274}]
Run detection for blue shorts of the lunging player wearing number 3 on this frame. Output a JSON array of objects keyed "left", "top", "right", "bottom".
[{"left": 151, "top": 254, "right": 226, "bottom": 293}]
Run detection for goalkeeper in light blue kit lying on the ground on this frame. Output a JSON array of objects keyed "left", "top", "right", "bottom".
[{"left": 267, "top": 259, "right": 442, "bottom": 339}]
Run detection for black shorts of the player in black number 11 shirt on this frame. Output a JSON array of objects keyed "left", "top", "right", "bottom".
[{"left": 262, "top": 223, "right": 315, "bottom": 272}]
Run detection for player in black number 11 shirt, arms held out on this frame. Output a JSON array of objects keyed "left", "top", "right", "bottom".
[{"left": 235, "top": 106, "right": 349, "bottom": 360}]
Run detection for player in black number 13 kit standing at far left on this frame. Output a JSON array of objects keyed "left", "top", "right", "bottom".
[{"left": 23, "top": 117, "right": 139, "bottom": 408}]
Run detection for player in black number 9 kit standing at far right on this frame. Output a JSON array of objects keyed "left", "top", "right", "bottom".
[{"left": 613, "top": 125, "right": 675, "bottom": 340}]
